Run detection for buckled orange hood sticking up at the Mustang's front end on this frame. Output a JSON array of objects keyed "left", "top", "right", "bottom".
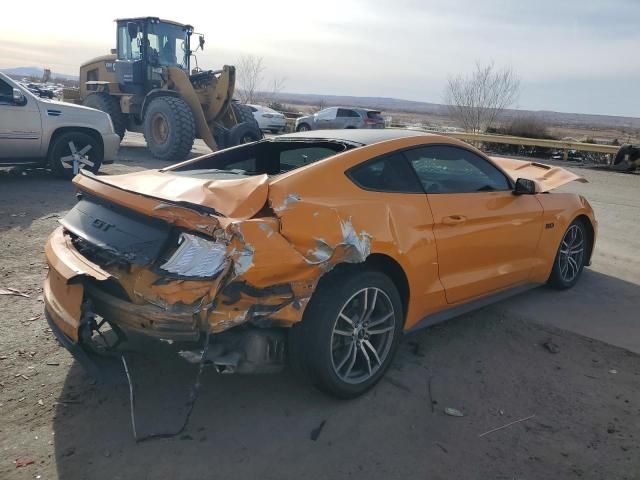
[{"left": 491, "top": 157, "right": 588, "bottom": 193}]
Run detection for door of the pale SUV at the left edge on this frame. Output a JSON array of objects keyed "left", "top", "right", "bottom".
[{"left": 0, "top": 78, "right": 42, "bottom": 161}]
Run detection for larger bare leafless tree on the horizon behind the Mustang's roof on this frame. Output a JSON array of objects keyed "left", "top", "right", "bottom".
[{"left": 444, "top": 62, "right": 520, "bottom": 133}]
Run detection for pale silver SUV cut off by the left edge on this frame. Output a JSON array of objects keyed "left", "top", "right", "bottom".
[{"left": 0, "top": 73, "right": 120, "bottom": 178}]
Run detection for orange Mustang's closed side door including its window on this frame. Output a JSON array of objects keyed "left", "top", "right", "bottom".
[{"left": 405, "top": 145, "right": 543, "bottom": 303}]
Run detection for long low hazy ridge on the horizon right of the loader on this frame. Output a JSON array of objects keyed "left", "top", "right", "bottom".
[{"left": 272, "top": 93, "right": 640, "bottom": 128}]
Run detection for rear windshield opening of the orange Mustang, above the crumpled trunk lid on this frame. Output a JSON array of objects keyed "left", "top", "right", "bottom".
[{"left": 165, "top": 140, "right": 352, "bottom": 178}]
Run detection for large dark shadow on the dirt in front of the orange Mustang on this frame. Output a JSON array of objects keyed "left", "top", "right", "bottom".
[{"left": 53, "top": 272, "right": 640, "bottom": 479}]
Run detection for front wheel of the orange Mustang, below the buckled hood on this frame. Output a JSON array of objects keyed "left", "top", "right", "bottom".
[{"left": 547, "top": 218, "right": 591, "bottom": 290}]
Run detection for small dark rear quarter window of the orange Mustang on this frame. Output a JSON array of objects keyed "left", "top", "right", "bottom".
[{"left": 347, "top": 153, "right": 424, "bottom": 193}]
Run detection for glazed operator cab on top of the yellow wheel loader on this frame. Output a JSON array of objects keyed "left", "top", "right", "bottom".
[{"left": 115, "top": 17, "right": 193, "bottom": 95}]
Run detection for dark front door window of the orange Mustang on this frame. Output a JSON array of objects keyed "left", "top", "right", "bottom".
[{"left": 404, "top": 145, "right": 511, "bottom": 193}]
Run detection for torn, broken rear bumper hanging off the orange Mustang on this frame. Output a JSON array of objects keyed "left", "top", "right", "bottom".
[{"left": 43, "top": 228, "right": 308, "bottom": 380}]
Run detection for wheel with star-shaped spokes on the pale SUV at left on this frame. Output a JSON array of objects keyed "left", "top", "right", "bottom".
[{"left": 48, "top": 132, "right": 104, "bottom": 179}]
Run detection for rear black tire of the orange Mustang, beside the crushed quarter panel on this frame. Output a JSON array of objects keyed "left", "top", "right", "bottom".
[{"left": 289, "top": 267, "right": 404, "bottom": 398}]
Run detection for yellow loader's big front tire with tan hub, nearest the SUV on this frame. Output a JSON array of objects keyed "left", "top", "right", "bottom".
[{"left": 144, "top": 96, "right": 196, "bottom": 162}]
